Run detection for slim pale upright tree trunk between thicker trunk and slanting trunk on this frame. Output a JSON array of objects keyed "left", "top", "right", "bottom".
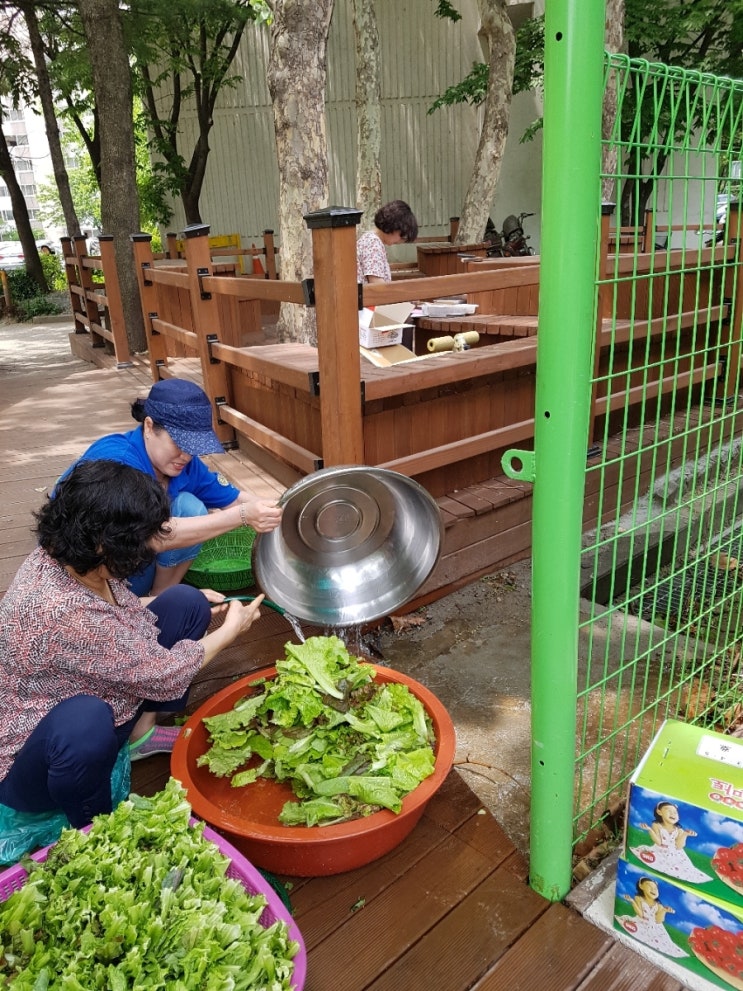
[{"left": 353, "top": 0, "right": 382, "bottom": 230}]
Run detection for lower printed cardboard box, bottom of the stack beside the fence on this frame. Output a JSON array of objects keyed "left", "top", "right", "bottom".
[{"left": 614, "top": 859, "right": 743, "bottom": 991}]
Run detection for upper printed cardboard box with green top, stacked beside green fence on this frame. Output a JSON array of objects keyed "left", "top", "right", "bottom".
[{"left": 624, "top": 720, "right": 743, "bottom": 906}]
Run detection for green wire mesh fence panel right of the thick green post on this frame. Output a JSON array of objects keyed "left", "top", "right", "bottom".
[{"left": 573, "top": 56, "right": 743, "bottom": 853}]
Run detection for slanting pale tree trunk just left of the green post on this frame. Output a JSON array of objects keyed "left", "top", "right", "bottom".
[{"left": 455, "top": 0, "right": 516, "bottom": 244}]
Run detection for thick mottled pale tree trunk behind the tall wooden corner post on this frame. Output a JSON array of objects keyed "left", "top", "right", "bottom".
[{"left": 268, "top": 0, "right": 333, "bottom": 344}]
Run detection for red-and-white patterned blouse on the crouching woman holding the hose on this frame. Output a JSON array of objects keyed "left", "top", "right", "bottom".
[{"left": 0, "top": 547, "right": 204, "bottom": 780}]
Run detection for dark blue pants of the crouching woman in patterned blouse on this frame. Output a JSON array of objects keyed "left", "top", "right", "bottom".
[{"left": 0, "top": 585, "right": 211, "bottom": 827}]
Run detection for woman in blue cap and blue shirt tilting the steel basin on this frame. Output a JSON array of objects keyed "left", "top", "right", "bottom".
[{"left": 62, "top": 378, "right": 282, "bottom": 601}]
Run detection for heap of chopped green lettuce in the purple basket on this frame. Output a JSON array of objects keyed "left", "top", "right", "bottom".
[{"left": 0, "top": 779, "right": 299, "bottom": 991}]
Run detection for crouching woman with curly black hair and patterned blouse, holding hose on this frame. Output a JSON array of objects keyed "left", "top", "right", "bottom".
[{"left": 0, "top": 460, "right": 263, "bottom": 827}]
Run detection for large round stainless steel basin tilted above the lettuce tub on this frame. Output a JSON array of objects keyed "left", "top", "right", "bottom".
[{"left": 252, "top": 465, "right": 443, "bottom": 627}]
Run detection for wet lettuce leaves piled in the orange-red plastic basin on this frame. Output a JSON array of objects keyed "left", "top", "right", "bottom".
[{"left": 198, "top": 637, "right": 435, "bottom": 826}]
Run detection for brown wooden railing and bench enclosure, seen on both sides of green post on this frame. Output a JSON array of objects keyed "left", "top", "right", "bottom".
[{"left": 67, "top": 209, "right": 741, "bottom": 504}]
